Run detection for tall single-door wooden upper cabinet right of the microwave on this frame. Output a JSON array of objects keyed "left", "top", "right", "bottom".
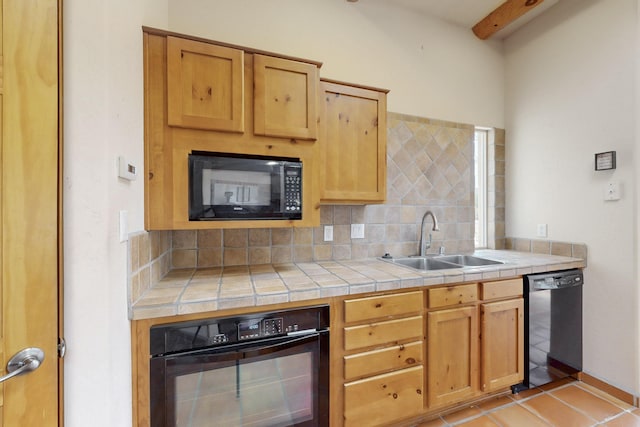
[{"left": 320, "top": 81, "right": 387, "bottom": 203}]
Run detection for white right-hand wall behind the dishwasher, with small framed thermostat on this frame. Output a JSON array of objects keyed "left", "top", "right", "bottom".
[{"left": 505, "top": 0, "right": 639, "bottom": 395}]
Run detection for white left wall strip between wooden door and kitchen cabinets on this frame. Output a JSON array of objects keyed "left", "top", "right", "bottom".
[{"left": 63, "top": 0, "right": 167, "bottom": 427}]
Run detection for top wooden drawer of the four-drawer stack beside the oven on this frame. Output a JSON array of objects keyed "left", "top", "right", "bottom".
[{"left": 344, "top": 291, "right": 422, "bottom": 323}]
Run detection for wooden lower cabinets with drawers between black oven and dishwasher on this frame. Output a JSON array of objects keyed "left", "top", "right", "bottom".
[{"left": 331, "top": 277, "right": 524, "bottom": 427}]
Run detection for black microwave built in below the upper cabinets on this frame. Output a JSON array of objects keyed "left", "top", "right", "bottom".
[{"left": 189, "top": 152, "right": 302, "bottom": 221}]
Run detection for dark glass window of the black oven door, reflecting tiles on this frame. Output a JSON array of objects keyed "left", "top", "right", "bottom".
[{"left": 159, "top": 335, "right": 320, "bottom": 427}]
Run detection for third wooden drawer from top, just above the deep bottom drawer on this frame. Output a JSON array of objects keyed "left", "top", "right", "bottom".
[{"left": 344, "top": 341, "right": 422, "bottom": 380}]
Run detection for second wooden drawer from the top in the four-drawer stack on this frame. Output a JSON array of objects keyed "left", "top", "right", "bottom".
[{"left": 344, "top": 316, "right": 424, "bottom": 350}]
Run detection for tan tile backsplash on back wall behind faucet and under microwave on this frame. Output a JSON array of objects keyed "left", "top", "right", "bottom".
[{"left": 172, "top": 113, "right": 474, "bottom": 268}]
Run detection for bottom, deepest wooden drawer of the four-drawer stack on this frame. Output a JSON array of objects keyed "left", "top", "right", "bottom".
[{"left": 344, "top": 366, "right": 424, "bottom": 427}]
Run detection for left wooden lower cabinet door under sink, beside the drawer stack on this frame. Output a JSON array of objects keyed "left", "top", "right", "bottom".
[{"left": 427, "top": 306, "right": 479, "bottom": 407}]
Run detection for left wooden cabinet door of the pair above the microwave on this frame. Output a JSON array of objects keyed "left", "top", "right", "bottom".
[{"left": 167, "top": 36, "right": 244, "bottom": 132}]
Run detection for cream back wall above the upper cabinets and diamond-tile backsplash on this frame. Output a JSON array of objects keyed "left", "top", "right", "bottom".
[{"left": 169, "top": 0, "right": 504, "bottom": 127}]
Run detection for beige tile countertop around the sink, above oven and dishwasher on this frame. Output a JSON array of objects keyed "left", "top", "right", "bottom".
[{"left": 129, "top": 249, "right": 586, "bottom": 320}]
